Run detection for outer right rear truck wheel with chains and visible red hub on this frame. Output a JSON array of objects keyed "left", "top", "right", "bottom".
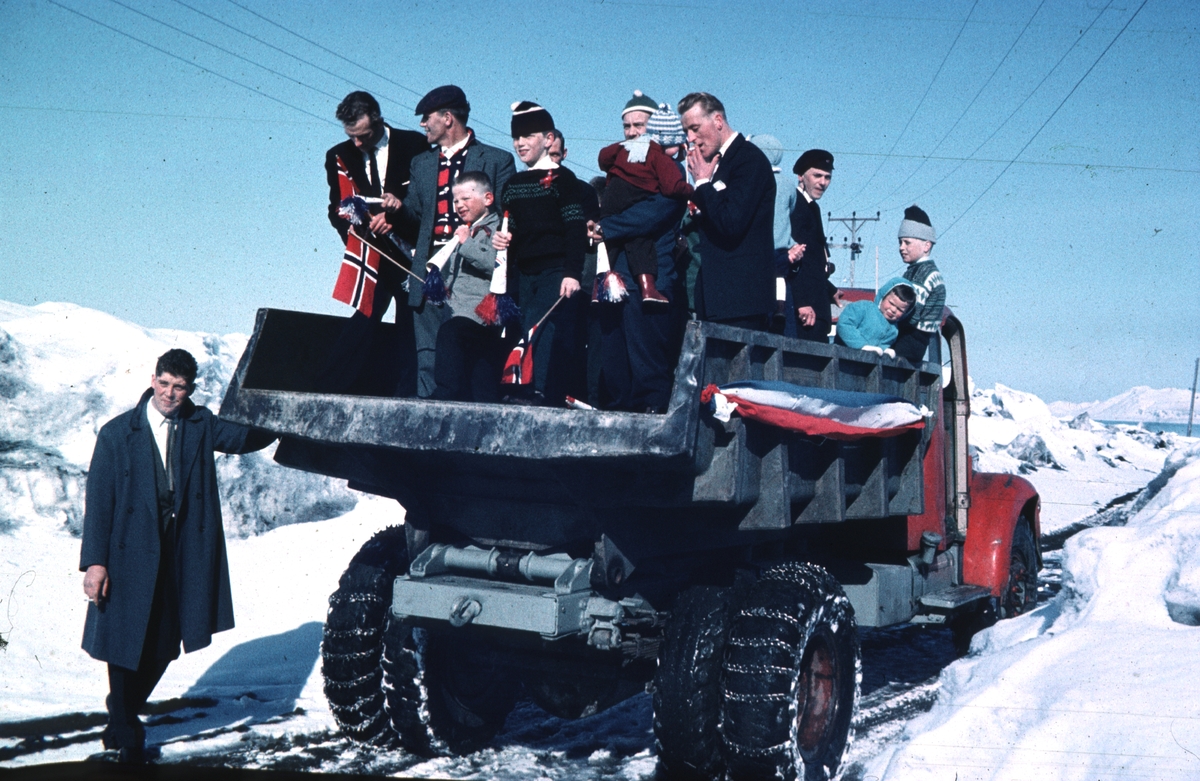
[{"left": 722, "top": 561, "right": 862, "bottom": 781}]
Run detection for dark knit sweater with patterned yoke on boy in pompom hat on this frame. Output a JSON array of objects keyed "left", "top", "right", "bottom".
[{"left": 500, "top": 167, "right": 595, "bottom": 280}]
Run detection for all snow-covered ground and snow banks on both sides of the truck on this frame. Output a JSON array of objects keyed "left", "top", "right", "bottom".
[{"left": 0, "top": 304, "right": 1200, "bottom": 781}]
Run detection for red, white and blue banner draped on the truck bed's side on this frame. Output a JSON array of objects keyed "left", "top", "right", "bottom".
[{"left": 700, "top": 380, "right": 932, "bottom": 439}]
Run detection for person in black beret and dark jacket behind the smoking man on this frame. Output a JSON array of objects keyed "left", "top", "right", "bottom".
[{"left": 786, "top": 149, "right": 833, "bottom": 342}]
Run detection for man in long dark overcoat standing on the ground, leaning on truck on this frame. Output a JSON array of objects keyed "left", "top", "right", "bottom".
[{"left": 79, "top": 349, "right": 274, "bottom": 763}]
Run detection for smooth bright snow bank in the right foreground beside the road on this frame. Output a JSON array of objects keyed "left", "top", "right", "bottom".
[{"left": 860, "top": 444, "right": 1200, "bottom": 781}]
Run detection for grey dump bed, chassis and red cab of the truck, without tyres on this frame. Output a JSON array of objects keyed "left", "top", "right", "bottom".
[{"left": 221, "top": 310, "right": 1039, "bottom": 777}]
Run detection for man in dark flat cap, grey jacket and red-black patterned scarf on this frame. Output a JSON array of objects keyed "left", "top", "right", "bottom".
[{"left": 402, "top": 84, "right": 516, "bottom": 397}]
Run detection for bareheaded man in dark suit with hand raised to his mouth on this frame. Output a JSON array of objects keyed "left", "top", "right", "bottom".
[{"left": 679, "top": 92, "right": 775, "bottom": 330}]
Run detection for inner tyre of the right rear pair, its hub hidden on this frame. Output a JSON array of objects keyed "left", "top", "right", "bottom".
[{"left": 654, "top": 585, "right": 731, "bottom": 779}]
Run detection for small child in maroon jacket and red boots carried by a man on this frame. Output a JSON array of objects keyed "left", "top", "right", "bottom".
[{"left": 600, "top": 91, "right": 692, "bottom": 307}]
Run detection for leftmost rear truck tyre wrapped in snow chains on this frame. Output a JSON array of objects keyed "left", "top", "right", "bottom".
[{"left": 320, "top": 527, "right": 408, "bottom": 745}]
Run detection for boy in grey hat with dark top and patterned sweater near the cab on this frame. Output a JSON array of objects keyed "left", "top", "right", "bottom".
[{"left": 892, "top": 205, "right": 946, "bottom": 364}]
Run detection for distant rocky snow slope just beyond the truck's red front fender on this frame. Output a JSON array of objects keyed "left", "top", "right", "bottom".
[{"left": 968, "top": 384, "right": 1176, "bottom": 534}]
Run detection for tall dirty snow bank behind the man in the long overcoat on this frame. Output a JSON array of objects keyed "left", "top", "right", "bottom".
[{"left": 0, "top": 302, "right": 359, "bottom": 536}]
